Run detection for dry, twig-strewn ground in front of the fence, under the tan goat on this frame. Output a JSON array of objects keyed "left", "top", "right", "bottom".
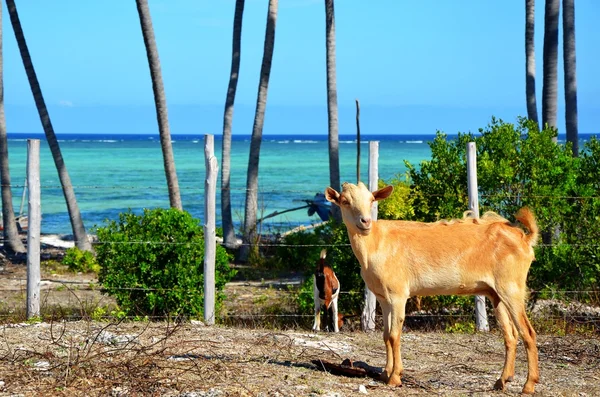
[{"left": 0, "top": 321, "right": 600, "bottom": 396}]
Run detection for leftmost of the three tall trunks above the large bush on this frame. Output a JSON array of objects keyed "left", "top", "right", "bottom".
[{"left": 525, "top": 0, "right": 539, "bottom": 128}]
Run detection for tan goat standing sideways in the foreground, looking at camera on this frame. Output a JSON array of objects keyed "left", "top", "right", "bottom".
[{"left": 325, "top": 183, "right": 539, "bottom": 393}]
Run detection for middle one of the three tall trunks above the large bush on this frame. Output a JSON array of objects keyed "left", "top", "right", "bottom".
[{"left": 542, "top": 0, "right": 560, "bottom": 135}]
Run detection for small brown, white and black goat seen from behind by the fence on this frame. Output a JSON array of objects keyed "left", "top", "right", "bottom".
[{"left": 313, "top": 249, "right": 341, "bottom": 332}]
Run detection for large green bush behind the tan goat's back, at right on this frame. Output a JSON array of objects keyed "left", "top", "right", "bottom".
[{"left": 407, "top": 118, "right": 600, "bottom": 290}]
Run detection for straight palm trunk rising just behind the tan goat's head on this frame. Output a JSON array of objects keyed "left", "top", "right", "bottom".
[{"left": 325, "top": 0, "right": 342, "bottom": 222}]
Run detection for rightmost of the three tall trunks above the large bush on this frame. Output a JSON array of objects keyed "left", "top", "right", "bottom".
[{"left": 563, "top": 0, "right": 579, "bottom": 157}]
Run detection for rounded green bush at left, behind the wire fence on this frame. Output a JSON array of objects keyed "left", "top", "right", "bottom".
[{"left": 96, "top": 208, "right": 235, "bottom": 317}]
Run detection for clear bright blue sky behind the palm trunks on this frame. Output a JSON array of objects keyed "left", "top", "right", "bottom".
[{"left": 3, "top": 0, "right": 600, "bottom": 135}]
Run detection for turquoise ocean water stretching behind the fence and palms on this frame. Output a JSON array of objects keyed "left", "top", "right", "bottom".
[{"left": 8, "top": 133, "right": 592, "bottom": 234}]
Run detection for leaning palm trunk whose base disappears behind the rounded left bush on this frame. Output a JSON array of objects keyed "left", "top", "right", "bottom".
[{"left": 136, "top": 0, "right": 183, "bottom": 210}]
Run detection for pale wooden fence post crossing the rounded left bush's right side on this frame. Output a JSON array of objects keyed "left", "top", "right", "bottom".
[{"left": 204, "top": 135, "right": 219, "bottom": 325}]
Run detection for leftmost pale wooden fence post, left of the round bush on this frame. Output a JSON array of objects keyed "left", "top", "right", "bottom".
[{"left": 27, "top": 139, "right": 42, "bottom": 319}]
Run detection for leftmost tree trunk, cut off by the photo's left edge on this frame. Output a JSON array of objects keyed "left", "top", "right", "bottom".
[{"left": 0, "top": 1, "right": 25, "bottom": 253}]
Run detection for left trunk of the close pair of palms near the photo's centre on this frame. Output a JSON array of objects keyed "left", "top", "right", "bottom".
[{"left": 221, "top": 0, "right": 245, "bottom": 248}]
